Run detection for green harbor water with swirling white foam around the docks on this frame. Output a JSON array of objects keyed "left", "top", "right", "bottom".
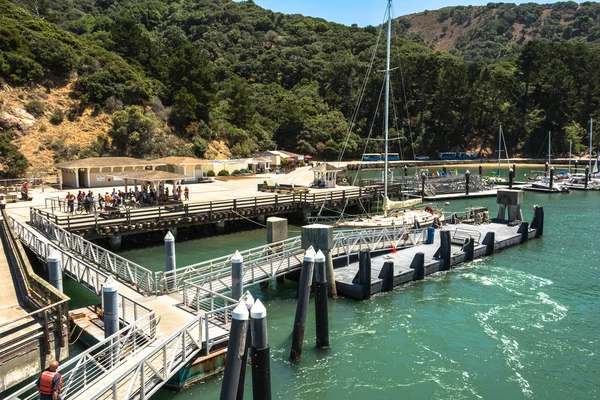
[{"left": 63, "top": 192, "right": 600, "bottom": 400}]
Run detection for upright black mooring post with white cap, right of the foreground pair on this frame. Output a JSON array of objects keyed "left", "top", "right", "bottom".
[{"left": 250, "top": 300, "right": 271, "bottom": 400}]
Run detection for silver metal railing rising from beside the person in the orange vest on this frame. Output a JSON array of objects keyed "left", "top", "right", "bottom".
[{"left": 8, "top": 313, "right": 155, "bottom": 400}]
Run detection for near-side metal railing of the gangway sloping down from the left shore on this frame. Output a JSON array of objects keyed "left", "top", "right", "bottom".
[{"left": 9, "top": 217, "right": 156, "bottom": 336}]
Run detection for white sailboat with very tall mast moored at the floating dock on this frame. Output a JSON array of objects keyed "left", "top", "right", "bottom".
[{"left": 333, "top": 0, "right": 444, "bottom": 228}]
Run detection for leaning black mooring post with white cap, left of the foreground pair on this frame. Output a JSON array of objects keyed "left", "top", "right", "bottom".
[{"left": 221, "top": 302, "right": 249, "bottom": 400}]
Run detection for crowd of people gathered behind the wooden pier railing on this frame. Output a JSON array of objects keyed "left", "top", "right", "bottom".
[{"left": 65, "top": 184, "right": 190, "bottom": 214}]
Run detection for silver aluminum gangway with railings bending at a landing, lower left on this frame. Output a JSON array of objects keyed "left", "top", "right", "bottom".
[{"left": 9, "top": 218, "right": 237, "bottom": 399}]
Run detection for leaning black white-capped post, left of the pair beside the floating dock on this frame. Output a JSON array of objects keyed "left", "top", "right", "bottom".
[{"left": 290, "top": 246, "right": 315, "bottom": 361}]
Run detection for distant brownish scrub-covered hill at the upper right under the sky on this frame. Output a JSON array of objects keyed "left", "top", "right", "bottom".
[{"left": 402, "top": 2, "right": 600, "bottom": 62}]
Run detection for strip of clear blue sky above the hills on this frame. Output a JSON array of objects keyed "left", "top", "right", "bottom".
[{"left": 239, "top": 0, "right": 580, "bottom": 26}]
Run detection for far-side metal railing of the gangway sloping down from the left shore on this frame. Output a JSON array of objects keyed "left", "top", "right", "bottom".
[{"left": 30, "top": 210, "right": 156, "bottom": 294}]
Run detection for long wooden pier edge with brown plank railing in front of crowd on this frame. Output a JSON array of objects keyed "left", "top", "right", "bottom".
[{"left": 32, "top": 187, "right": 400, "bottom": 239}]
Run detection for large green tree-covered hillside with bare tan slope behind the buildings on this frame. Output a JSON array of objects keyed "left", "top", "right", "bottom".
[{"left": 0, "top": 0, "right": 600, "bottom": 173}]
